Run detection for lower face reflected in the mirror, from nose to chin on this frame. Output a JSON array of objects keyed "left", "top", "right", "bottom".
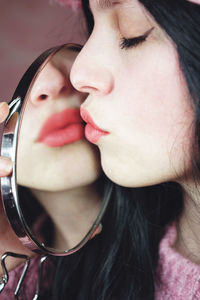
[{"left": 17, "top": 48, "right": 101, "bottom": 191}]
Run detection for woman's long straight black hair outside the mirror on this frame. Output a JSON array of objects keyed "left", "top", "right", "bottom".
[{"left": 50, "top": 0, "right": 200, "bottom": 300}]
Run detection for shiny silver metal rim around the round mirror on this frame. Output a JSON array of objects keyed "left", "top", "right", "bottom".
[{"left": 1, "top": 43, "right": 113, "bottom": 256}]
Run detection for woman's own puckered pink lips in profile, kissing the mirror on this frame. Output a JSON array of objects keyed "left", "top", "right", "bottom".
[{"left": 81, "top": 108, "right": 109, "bottom": 144}]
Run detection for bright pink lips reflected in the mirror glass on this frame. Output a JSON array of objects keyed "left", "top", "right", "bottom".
[{"left": 37, "top": 108, "right": 84, "bottom": 147}]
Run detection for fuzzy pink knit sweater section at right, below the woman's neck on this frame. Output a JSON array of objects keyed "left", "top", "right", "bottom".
[{"left": 155, "top": 223, "right": 200, "bottom": 300}]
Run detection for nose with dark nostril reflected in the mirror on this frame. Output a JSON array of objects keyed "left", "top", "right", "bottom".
[{"left": 30, "top": 62, "right": 73, "bottom": 105}]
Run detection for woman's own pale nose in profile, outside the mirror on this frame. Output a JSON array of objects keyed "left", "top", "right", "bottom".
[{"left": 70, "top": 44, "right": 114, "bottom": 95}]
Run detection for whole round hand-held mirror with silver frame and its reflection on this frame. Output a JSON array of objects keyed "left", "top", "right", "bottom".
[{"left": 1, "top": 44, "right": 112, "bottom": 255}]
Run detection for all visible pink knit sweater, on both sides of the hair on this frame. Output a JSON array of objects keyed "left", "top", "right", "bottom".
[{"left": 0, "top": 223, "right": 200, "bottom": 300}]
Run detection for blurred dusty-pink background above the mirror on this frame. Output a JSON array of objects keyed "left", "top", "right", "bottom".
[{"left": 0, "top": 0, "right": 86, "bottom": 102}]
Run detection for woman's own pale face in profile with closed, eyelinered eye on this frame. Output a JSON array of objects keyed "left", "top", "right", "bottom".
[{"left": 71, "top": 0, "right": 193, "bottom": 187}]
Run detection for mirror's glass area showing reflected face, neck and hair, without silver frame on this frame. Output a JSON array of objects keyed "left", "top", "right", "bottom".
[{"left": 7, "top": 45, "right": 109, "bottom": 253}]
